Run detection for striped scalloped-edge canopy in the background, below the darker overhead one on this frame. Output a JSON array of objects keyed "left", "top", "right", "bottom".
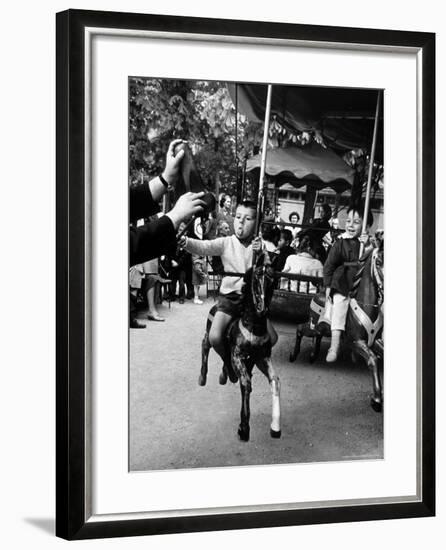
[{"left": 246, "top": 142, "right": 355, "bottom": 193}]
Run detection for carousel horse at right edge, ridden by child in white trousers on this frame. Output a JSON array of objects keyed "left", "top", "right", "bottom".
[{"left": 290, "top": 241, "right": 384, "bottom": 412}]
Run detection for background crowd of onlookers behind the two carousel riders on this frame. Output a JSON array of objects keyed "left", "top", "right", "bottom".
[{"left": 130, "top": 188, "right": 350, "bottom": 328}]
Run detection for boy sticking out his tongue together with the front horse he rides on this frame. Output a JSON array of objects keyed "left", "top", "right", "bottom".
[{"left": 182, "top": 201, "right": 281, "bottom": 441}]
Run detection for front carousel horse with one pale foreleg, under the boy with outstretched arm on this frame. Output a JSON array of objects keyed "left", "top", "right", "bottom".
[{"left": 198, "top": 252, "right": 281, "bottom": 441}]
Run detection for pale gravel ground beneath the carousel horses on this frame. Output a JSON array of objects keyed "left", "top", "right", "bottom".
[{"left": 130, "top": 299, "right": 383, "bottom": 471}]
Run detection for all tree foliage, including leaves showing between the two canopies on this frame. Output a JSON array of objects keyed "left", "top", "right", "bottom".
[{"left": 129, "top": 78, "right": 382, "bottom": 211}]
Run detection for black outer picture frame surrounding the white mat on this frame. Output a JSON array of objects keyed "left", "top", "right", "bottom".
[{"left": 56, "top": 10, "right": 435, "bottom": 540}]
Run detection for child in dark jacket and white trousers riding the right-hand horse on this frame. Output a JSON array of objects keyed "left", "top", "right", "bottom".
[{"left": 324, "top": 205, "right": 373, "bottom": 363}]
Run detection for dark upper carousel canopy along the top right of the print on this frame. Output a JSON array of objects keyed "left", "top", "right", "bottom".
[{"left": 228, "top": 83, "right": 382, "bottom": 159}]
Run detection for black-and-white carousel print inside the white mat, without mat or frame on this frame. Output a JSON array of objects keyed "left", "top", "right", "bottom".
[{"left": 128, "top": 76, "right": 386, "bottom": 472}]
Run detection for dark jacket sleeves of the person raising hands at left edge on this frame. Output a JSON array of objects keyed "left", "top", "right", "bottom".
[{"left": 129, "top": 184, "right": 176, "bottom": 266}]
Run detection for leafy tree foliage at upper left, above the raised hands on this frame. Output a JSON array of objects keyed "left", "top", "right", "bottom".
[{"left": 129, "top": 78, "right": 247, "bottom": 193}]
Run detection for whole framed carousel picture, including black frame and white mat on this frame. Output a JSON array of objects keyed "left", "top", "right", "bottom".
[{"left": 49, "top": 5, "right": 435, "bottom": 545}]
